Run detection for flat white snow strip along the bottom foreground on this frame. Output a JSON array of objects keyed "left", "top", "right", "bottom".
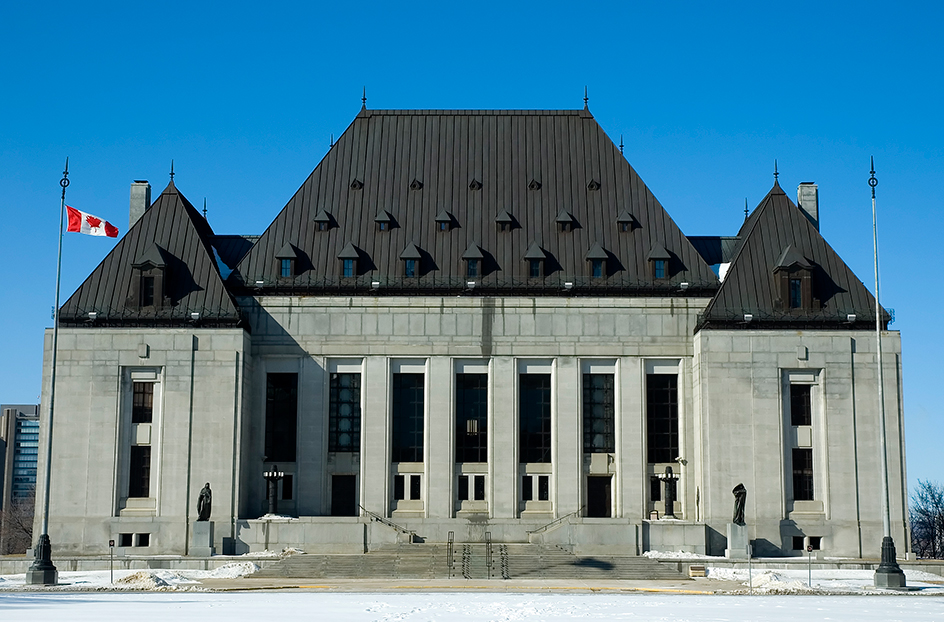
[{"left": 0, "top": 591, "right": 944, "bottom": 622}]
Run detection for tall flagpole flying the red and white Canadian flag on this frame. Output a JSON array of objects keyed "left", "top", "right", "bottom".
[{"left": 26, "top": 157, "right": 69, "bottom": 585}]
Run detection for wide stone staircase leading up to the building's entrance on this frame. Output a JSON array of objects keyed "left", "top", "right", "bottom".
[{"left": 251, "top": 542, "right": 687, "bottom": 580}]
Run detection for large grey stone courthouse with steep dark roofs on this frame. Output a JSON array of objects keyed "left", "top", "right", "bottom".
[{"left": 35, "top": 108, "right": 908, "bottom": 557}]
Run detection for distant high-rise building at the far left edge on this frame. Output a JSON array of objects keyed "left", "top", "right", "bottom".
[{"left": 0, "top": 404, "right": 39, "bottom": 553}]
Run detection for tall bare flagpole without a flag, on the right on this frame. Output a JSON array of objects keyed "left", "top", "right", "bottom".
[{"left": 869, "top": 158, "right": 905, "bottom": 588}]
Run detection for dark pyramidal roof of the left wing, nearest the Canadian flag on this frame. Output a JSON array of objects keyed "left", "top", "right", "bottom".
[{"left": 59, "top": 181, "right": 240, "bottom": 326}]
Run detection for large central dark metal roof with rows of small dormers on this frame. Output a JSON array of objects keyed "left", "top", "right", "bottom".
[{"left": 229, "top": 110, "right": 718, "bottom": 295}]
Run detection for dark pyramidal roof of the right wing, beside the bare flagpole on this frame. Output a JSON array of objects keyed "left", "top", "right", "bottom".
[{"left": 699, "top": 182, "right": 888, "bottom": 329}]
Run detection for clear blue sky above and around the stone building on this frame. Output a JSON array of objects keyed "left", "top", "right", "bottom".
[{"left": 0, "top": 2, "right": 944, "bottom": 492}]
